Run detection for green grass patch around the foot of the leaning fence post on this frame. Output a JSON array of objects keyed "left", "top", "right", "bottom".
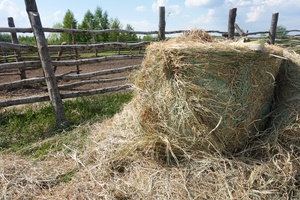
[{"left": 0, "top": 93, "right": 132, "bottom": 158}]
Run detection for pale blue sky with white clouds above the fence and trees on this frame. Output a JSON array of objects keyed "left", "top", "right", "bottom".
[{"left": 0, "top": 0, "right": 300, "bottom": 32}]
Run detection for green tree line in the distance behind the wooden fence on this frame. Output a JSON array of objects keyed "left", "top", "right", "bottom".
[{"left": 0, "top": 6, "right": 157, "bottom": 45}]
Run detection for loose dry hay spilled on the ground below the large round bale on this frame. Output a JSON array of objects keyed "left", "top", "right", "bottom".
[{"left": 45, "top": 102, "right": 299, "bottom": 200}]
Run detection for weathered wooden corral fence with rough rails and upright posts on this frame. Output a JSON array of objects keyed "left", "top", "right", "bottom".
[{"left": 0, "top": 0, "right": 300, "bottom": 124}]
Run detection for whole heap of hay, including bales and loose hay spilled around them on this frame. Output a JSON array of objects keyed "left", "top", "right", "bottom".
[{"left": 1, "top": 31, "right": 300, "bottom": 200}]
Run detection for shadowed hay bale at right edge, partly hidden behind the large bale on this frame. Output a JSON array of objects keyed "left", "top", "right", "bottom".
[{"left": 264, "top": 50, "right": 300, "bottom": 148}]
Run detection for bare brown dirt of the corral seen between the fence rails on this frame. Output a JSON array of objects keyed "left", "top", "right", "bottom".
[{"left": 0, "top": 58, "right": 142, "bottom": 101}]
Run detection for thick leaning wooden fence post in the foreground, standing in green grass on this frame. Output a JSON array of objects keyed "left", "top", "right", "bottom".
[{"left": 25, "top": 0, "right": 68, "bottom": 126}]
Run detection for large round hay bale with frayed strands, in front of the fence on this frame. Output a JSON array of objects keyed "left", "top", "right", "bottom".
[{"left": 132, "top": 36, "right": 282, "bottom": 157}]
